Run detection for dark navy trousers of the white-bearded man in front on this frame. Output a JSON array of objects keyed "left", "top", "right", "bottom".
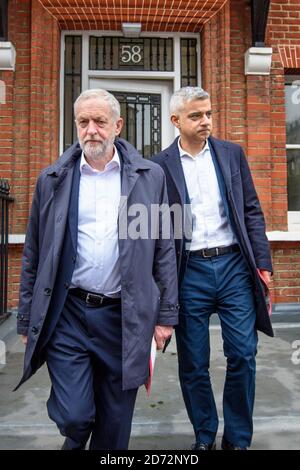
[{"left": 46, "top": 294, "right": 137, "bottom": 450}]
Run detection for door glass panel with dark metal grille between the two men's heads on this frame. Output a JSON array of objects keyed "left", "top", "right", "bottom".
[{"left": 110, "top": 91, "right": 161, "bottom": 158}]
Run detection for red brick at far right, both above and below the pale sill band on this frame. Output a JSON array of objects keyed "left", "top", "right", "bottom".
[{"left": 266, "top": 0, "right": 300, "bottom": 303}]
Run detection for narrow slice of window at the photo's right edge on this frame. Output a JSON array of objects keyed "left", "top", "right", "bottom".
[{"left": 285, "top": 74, "right": 300, "bottom": 212}]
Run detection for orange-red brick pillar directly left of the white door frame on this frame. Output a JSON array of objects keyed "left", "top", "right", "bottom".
[{"left": 28, "top": 0, "right": 60, "bottom": 201}]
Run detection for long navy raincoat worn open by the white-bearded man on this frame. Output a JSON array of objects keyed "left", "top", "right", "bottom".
[{"left": 18, "top": 139, "right": 178, "bottom": 389}]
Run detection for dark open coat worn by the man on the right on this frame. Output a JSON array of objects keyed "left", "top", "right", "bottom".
[{"left": 153, "top": 137, "right": 274, "bottom": 336}]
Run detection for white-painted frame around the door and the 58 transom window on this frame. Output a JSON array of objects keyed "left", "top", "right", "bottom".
[{"left": 59, "top": 30, "right": 201, "bottom": 153}]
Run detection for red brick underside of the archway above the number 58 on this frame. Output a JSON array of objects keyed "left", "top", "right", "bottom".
[{"left": 39, "top": 0, "right": 227, "bottom": 32}]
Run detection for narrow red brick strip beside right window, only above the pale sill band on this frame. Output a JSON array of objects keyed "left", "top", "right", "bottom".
[{"left": 267, "top": 0, "right": 300, "bottom": 230}]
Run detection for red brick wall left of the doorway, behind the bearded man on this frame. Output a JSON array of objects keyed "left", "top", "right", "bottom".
[{"left": 0, "top": 0, "right": 60, "bottom": 307}]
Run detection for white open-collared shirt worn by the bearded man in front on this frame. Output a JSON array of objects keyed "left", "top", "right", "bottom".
[{"left": 71, "top": 147, "right": 121, "bottom": 295}]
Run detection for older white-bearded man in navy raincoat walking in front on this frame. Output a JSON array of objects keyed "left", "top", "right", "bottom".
[{"left": 18, "top": 90, "right": 178, "bottom": 450}]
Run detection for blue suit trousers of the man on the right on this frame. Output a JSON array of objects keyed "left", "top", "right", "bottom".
[{"left": 176, "top": 253, "right": 257, "bottom": 447}]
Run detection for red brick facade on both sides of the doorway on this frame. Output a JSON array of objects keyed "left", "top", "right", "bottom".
[{"left": 0, "top": 0, "right": 300, "bottom": 307}]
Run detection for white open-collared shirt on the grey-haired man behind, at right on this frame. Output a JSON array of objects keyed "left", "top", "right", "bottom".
[{"left": 178, "top": 139, "right": 237, "bottom": 251}]
